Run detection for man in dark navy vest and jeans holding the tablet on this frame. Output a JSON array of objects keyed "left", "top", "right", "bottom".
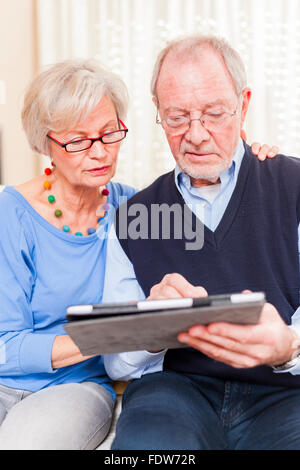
[{"left": 103, "top": 37, "right": 300, "bottom": 449}]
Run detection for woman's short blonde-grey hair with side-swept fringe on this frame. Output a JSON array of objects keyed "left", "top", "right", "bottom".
[{"left": 22, "top": 59, "right": 128, "bottom": 155}]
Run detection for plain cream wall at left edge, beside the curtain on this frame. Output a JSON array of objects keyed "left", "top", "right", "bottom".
[{"left": 0, "top": 0, "right": 38, "bottom": 184}]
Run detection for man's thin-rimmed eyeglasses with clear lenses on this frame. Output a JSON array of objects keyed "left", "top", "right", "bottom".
[{"left": 156, "top": 105, "right": 238, "bottom": 135}]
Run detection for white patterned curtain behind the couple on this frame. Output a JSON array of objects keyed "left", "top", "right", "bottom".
[{"left": 37, "top": 0, "right": 300, "bottom": 188}]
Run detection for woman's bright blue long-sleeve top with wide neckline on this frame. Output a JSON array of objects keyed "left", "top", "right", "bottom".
[{"left": 0, "top": 183, "right": 135, "bottom": 397}]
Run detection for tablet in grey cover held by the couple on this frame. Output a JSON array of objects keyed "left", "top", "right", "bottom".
[{"left": 64, "top": 292, "right": 265, "bottom": 355}]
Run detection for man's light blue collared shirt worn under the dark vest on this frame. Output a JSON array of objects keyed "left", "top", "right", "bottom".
[{"left": 103, "top": 139, "right": 300, "bottom": 380}]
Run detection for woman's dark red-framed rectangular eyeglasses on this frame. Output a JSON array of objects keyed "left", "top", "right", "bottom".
[{"left": 47, "top": 120, "right": 128, "bottom": 153}]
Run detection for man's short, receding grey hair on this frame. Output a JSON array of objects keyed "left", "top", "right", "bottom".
[{"left": 151, "top": 35, "right": 247, "bottom": 97}]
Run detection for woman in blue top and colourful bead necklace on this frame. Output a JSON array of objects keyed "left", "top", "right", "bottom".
[{"left": 0, "top": 61, "right": 276, "bottom": 449}]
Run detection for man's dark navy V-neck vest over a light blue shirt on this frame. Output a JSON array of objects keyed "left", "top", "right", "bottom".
[{"left": 116, "top": 145, "right": 300, "bottom": 387}]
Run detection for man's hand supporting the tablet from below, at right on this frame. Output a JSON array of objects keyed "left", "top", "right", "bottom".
[{"left": 178, "top": 303, "right": 300, "bottom": 368}]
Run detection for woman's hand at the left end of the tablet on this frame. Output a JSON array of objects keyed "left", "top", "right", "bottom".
[{"left": 51, "top": 335, "right": 93, "bottom": 369}]
